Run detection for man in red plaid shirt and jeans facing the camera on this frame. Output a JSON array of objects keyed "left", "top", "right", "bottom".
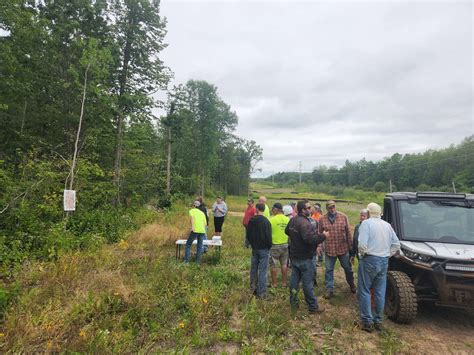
[{"left": 319, "top": 201, "right": 356, "bottom": 298}]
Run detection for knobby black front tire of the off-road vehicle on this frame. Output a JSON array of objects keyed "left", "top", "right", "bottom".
[{"left": 385, "top": 271, "right": 418, "bottom": 324}]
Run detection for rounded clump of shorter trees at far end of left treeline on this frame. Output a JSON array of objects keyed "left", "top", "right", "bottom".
[{"left": 161, "top": 80, "right": 262, "bottom": 195}]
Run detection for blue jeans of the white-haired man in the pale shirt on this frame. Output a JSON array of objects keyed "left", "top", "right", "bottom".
[{"left": 357, "top": 255, "right": 388, "bottom": 325}]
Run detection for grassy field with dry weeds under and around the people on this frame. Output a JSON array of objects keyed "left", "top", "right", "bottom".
[{"left": 0, "top": 188, "right": 474, "bottom": 354}]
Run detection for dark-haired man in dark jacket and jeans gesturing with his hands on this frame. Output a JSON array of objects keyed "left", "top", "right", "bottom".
[{"left": 285, "top": 201, "right": 329, "bottom": 313}]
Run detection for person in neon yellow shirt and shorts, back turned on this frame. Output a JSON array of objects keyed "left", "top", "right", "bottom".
[{"left": 270, "top": 202, "right": 290, "bottom": 287}]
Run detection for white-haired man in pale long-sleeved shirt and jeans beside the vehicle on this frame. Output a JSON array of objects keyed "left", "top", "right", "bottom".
[{"left": 357, "top": 203, "right": 400, "bottom": 332}]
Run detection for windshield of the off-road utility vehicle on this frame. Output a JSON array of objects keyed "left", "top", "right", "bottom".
[{"left": 400, "top": 201, "right": 474, "bottom": 244}]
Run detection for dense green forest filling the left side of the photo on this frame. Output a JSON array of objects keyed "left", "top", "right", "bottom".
[{"left": 0, "top": 0, "right": 262, "bottom": 271}]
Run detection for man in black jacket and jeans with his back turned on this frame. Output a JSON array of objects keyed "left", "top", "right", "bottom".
[{"left": 246, "top": 203, "right": 272, "bottom": 298}]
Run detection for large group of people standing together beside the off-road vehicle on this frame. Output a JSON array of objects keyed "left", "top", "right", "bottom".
[{"left": 243, "top": 196, "right": 400, "bottom": 332}]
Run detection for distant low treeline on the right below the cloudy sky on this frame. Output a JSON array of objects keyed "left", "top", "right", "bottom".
[{"left": 265, "top": 136, "right": 474, "bottom": 193}]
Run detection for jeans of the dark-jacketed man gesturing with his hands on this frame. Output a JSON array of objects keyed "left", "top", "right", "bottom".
[{"left": 290, "top": 259, "right": 319, "bottom": 311}]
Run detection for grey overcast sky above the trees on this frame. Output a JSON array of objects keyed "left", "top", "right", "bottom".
[{"left": 162, "top": 0, "right": 474, "bottom": 176}]
